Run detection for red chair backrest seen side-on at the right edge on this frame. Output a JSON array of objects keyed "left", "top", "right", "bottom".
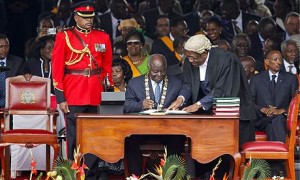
[{"left": 287, "top": 91, "right": 300, "bottom": 149}]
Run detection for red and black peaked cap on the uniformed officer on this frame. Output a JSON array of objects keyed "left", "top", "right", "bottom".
[{"left": 72, "top": 1, "right": 95, "bottom": 17}]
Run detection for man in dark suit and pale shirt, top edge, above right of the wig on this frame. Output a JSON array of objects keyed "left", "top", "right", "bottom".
[{"left": 221, "top": 0, "right": 260, "bottom": 39}]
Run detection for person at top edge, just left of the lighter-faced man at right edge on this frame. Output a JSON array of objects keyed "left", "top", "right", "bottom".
[{"left": 272, "top": 0, "right": 294, "bottom": 33}]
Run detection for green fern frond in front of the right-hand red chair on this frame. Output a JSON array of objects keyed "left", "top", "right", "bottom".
[{"left": 242, "top": 159, "right": 271, "bottom": 180}]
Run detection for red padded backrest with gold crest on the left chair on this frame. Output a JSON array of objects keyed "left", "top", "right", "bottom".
[{"left": 5, "top": 74, "right": 51, "bottom": 111}]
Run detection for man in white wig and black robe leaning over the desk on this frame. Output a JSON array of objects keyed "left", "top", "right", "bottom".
[{"left": 169, "top": 35, "right": 256, "bottom": 146}]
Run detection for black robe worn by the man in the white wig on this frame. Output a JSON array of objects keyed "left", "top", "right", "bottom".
[{"left": 183, "top": 48, "right": 256, "bottom": 120}]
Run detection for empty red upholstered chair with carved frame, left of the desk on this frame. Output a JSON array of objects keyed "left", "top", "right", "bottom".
[{"left": 0, "top": 74, "right": 59, "bottom": 179}]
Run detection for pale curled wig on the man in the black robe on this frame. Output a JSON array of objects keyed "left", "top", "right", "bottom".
[{"left": 184, "top": 34, "right": 212, "bottom": 54}]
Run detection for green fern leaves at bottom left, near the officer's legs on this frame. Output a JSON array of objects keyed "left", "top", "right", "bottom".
[{"left": 54, "top": 158, "right": 76, "bottom": 180}]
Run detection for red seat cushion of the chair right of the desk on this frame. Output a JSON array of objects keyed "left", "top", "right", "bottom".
[{"left": 242, "top": 141, "right": 288, "bottom": 152}]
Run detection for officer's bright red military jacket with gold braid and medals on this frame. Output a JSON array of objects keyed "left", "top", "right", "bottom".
[{"left": 52, "top": 29, "right": 112, "bottom": 105}]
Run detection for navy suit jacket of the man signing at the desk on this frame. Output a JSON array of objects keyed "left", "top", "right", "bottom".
[{"left": 124, "top": 75, "right": 191, "bottom": 113}]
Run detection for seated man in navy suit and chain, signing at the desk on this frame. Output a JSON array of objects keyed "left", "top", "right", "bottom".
[{"left": 124, "top": 54, "right": 191, "bottom": 175}]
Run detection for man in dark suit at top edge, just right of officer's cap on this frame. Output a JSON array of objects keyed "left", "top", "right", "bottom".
[{"left": 99, "top": 0, "right": 130, "bottom": 41}]
